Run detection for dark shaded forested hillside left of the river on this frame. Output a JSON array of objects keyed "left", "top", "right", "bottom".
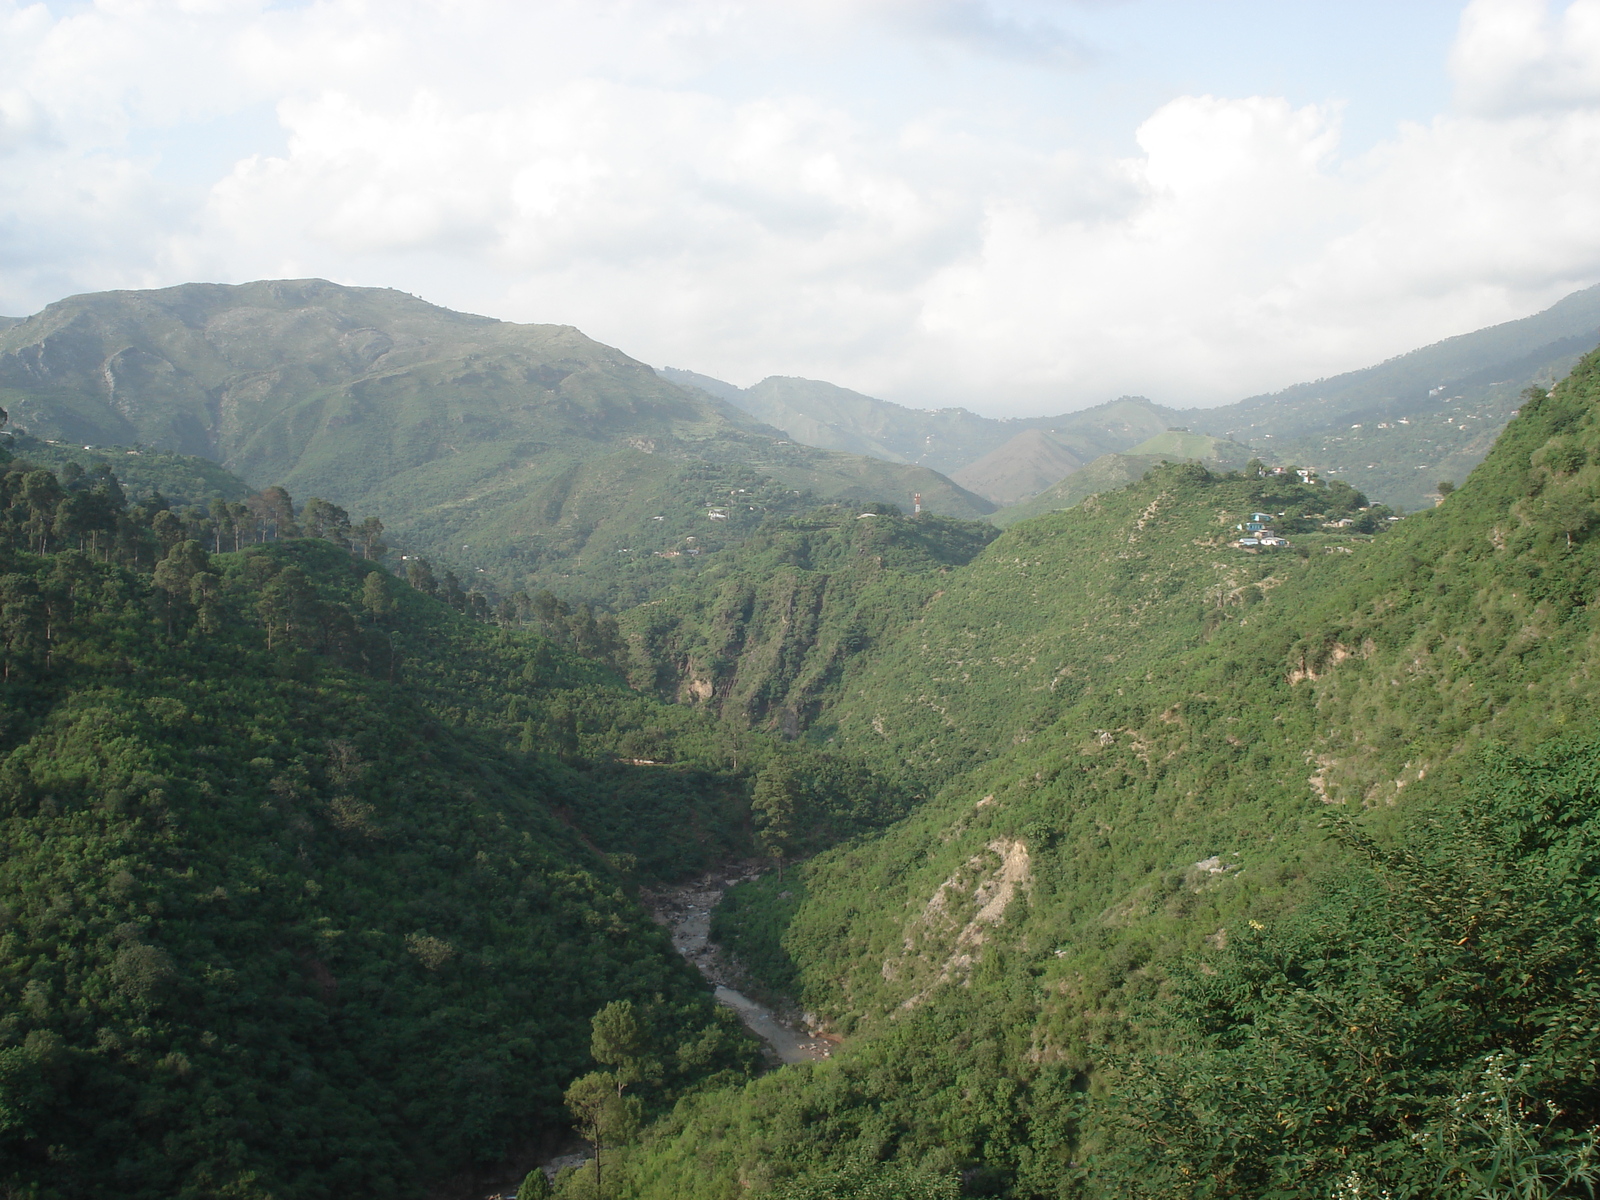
[{"left": 0, "top": 435, "right": 934, "bottom": 1198}]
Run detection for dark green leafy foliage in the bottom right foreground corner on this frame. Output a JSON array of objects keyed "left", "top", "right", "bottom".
[{"left": 1091, "top": 744, "right": 1600, "bottom": 1197}]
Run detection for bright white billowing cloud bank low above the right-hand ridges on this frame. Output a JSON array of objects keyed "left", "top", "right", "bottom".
[{"left": 923, "top": 78, "right": 1600, "bottom": 408}]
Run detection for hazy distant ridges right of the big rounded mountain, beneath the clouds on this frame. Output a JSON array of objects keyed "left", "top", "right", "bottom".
[{"left": 662, "top": 286, "right": 1600, "bottom": 509}]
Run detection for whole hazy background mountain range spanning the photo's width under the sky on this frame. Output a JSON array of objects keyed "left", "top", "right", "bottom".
[{"left": 12, "top": 280, "right": 1600, "bottom": 588}]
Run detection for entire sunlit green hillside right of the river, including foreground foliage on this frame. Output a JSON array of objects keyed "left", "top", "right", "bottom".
[{"left": 592, "top": 358, "right": 1600, "bottom": 1197}]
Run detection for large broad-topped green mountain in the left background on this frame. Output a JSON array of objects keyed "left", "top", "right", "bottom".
[{"left": 0, "top": 280, "right": 994, "bottom": 598}]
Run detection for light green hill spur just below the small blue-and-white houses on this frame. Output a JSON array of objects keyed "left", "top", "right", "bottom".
[{"left": 819, "top": 466, "right": 1382, "bottom": 776}]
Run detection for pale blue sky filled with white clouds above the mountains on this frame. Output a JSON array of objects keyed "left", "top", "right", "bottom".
[{"left": 0, "top": 0, "right": 1600, "bottom": 416}]
